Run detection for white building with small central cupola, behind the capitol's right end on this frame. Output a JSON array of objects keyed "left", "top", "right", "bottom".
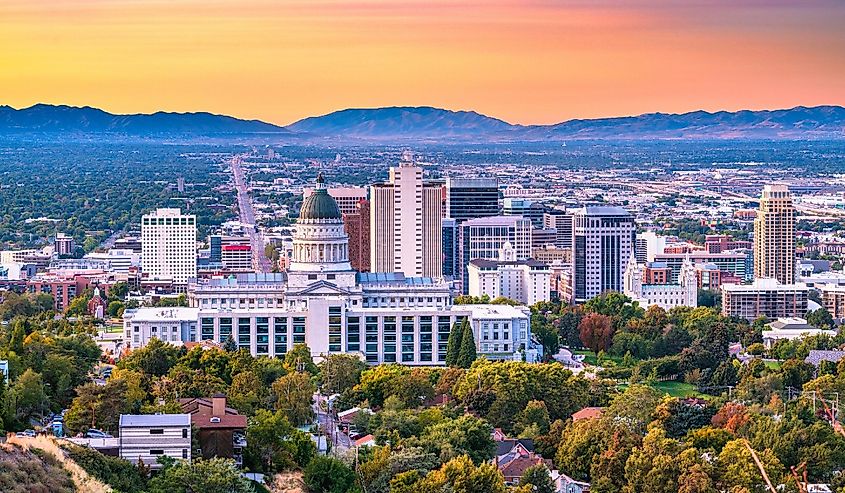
[{"left": 467, "top": 243, "right": 551, "bottom": 305}]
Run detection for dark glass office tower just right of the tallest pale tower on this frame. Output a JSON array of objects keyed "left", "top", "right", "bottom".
[{"left": 446, "top": 177, "right": 499, "bottom": 224}]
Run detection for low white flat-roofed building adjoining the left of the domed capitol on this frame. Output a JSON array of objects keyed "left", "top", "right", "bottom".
[{"left": 123, "top": 307, "right": 199, "bottom": 349}]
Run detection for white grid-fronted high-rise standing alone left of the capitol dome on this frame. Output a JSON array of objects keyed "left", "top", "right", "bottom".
[{"left": 141, "top": 209, "right": 197, "bottom": 285}]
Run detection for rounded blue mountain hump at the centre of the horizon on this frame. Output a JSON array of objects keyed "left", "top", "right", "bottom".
[{"left": 288, "top": 106, "right": 520, "bottom": 139}]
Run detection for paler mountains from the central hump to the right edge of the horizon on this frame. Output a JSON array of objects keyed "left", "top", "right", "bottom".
[{"left": 288, "top": 106, "right": 845, "bottom": 140}]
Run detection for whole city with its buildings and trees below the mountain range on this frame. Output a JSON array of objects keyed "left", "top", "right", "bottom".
[{"left": 0, "top": 138, "right": 845, "bottom": 493}]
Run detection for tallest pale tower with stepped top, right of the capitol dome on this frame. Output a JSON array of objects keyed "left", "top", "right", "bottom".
[{"left": 370, "top": 156, "right": 443, "bottom": 277}]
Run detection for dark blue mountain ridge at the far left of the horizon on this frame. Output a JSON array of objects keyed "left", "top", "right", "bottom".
[{"left": 0, "top": 104, "right": 289, "bottom": 135}]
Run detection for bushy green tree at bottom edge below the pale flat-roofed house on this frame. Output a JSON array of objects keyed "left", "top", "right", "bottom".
[{"left": 149, "top": 457, "right": 254, "bottom": 493}]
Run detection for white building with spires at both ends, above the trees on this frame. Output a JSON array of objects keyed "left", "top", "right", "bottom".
[{"left": 624, "top": 257, "right": 698, "bottom": 310}]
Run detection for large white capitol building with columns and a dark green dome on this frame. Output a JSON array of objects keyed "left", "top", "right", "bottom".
[{"left": 181, "top": 174, "right": 537, "bottom": 365}]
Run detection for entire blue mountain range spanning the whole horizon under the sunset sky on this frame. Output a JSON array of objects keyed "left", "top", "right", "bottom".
[{"left": 0, "top": 104, "right": 845, "bottom": 142}]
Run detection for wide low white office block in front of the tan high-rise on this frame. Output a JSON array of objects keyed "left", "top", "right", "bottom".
[{"left": 721, "top": 278, "right": 810, "bottom": 321}]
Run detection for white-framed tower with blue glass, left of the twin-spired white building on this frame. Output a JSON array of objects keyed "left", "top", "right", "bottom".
[{"left": 572, "top": 207, "right": 636, "bottom": 302}]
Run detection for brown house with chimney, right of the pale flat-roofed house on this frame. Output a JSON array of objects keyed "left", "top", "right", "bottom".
[{"left": 179, "top": 394, "right": 247, "bottom": 465}]
